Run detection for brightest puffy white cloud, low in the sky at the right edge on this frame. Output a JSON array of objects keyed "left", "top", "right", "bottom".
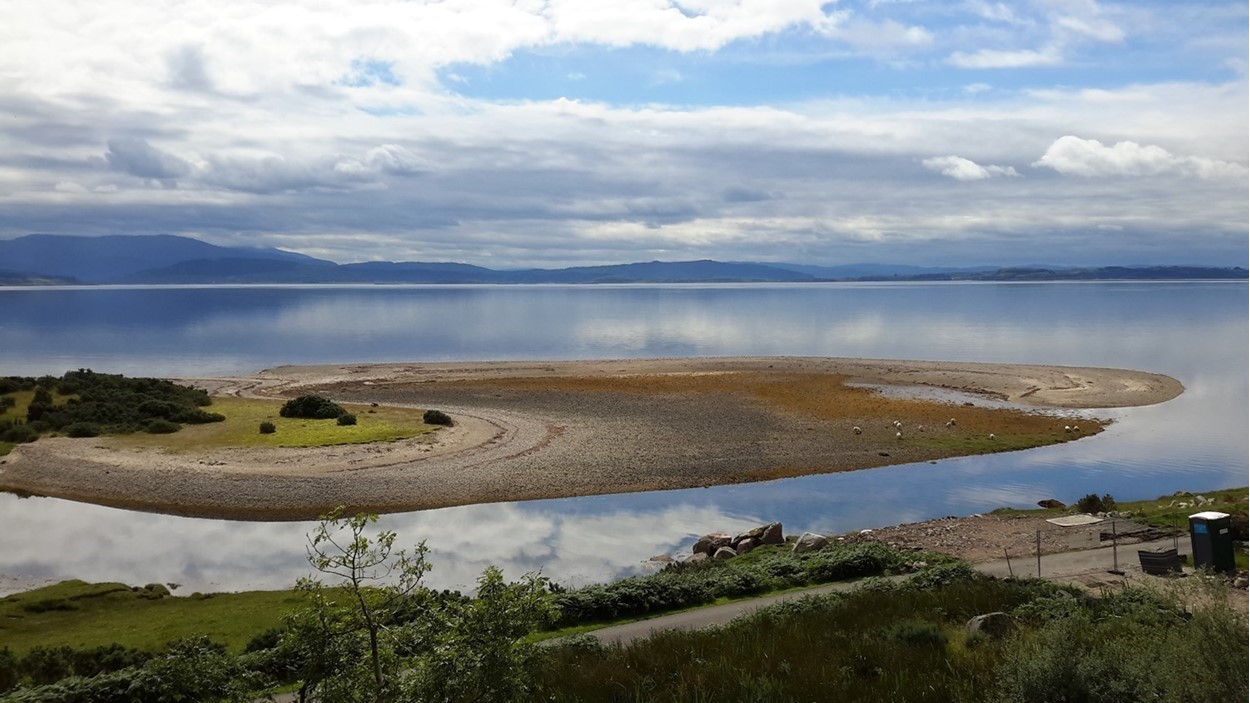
[{"left": 1033, "top": 135, "right": 1246, "bottom": 179}]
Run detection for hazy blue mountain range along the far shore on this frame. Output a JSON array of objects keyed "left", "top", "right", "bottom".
[{"left": 0, "top": 234, "right": 1246, "bottom": 285}]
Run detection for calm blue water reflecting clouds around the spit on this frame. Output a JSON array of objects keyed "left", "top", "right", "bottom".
[{"left": 0, "top": 283, "right": 1248, "bottom": 593}]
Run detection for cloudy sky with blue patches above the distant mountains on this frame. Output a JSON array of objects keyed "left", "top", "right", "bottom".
[{"left": 0, "top": 0, "right": 1250, "bottom": 268}]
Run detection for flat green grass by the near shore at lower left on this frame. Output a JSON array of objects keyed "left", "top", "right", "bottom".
[{"left": 0, "top": 580, "right": 303, "bottom": 655}]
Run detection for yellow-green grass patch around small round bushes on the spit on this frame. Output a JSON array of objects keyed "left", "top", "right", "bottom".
[{"left": 118, "top": 398, "right": 438, "bottom": 452}]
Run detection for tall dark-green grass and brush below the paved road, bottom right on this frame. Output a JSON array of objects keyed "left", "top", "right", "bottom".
[{"left": 543, "top": 570, "right": 1246, "bottom": 703}]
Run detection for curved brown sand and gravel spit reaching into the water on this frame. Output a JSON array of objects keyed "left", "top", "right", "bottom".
[{"left": 0, "top": 358, "right": 1183, "bottom": 520}]
